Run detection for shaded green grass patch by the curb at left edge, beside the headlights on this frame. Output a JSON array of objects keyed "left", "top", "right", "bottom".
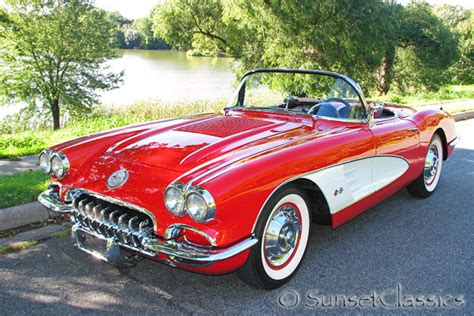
[{"left": 0, "top": 171, "right": 49, "bottom": 209}]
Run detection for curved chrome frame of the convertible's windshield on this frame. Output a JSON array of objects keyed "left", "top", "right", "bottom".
[{"left": 227, "top": 68, "right": 371, "bottom": 123}]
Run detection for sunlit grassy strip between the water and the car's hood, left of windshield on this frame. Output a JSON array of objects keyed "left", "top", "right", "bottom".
[{"left": 0, "top": 100, "right": 226, "bottom": 159}]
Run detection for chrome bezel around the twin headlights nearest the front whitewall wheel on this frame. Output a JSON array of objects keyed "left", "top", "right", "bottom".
[{"left": 164, "top": 182, "right": 216, "bottom": 223}]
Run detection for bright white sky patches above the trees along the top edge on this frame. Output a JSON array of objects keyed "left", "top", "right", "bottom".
[{"left": 95, "top": 0, "right": 474, "bottom": 19}]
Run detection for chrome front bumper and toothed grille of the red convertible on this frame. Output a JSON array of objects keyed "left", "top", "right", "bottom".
[{"left": 38, "top": 189, "right": 258, "bottom": 263}]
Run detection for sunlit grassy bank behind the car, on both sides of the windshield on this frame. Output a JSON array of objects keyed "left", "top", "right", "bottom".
[{"left": 0, "top": 85, "right": 474, "bottom": 159}]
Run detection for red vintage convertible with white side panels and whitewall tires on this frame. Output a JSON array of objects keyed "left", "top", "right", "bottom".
[{"left": 39, "top": 69, "right": 458, "bottom": 289}]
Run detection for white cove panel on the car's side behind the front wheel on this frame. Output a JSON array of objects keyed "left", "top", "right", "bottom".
[{"left": 303, "top": 156, "right": 409, "bottom": 214}]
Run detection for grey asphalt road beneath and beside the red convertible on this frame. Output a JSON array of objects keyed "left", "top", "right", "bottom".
[{"left": 0, "top": 120, "right": 474, "bottom": 315}]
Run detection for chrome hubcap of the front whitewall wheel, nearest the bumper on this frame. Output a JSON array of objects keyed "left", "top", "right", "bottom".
[{"left": 264, "top": 205, "right": 301, "bottom": 267}]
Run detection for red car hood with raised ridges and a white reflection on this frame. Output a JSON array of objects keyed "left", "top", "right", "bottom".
[{"left": 100, "top": 116, "right": 312, "bottom": 172}]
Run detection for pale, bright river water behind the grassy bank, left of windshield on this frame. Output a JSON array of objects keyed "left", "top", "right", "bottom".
[{"left": 0, "top": 49, "right": 236, "bottom": 120}]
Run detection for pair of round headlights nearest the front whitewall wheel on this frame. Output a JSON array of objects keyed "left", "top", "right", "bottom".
[{"left": 164, "top": 183, "right": 216, "bottom": 223}]
